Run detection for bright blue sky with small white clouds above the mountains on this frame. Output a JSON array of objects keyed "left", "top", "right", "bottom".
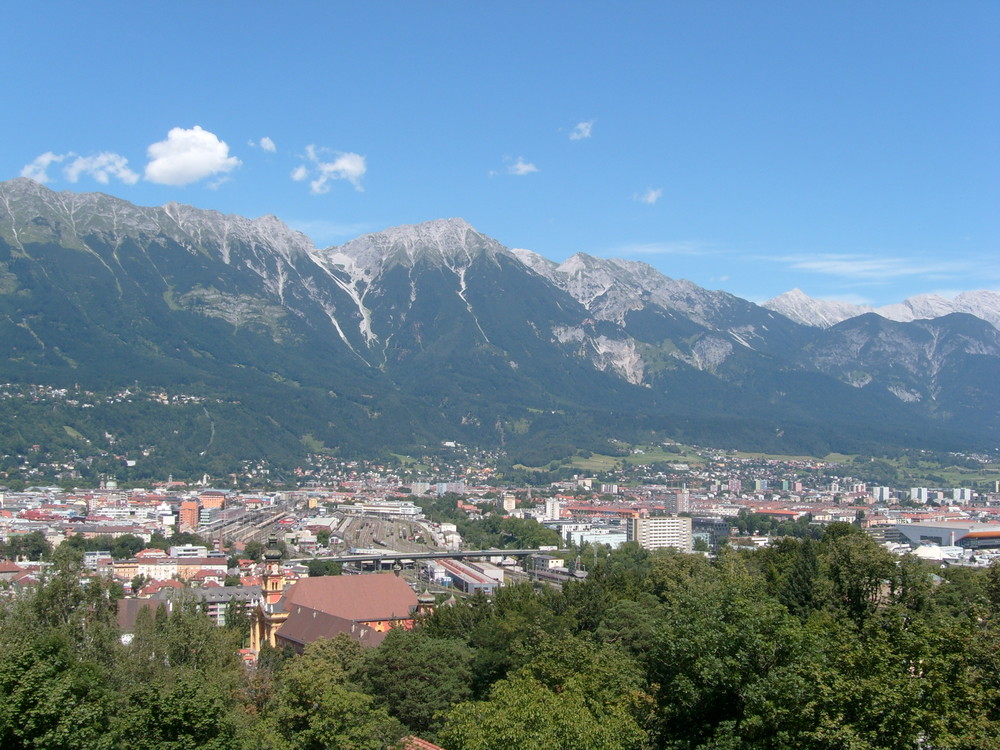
[{"left": 0, "top": 0, "right": 1000, "bottom": 305}]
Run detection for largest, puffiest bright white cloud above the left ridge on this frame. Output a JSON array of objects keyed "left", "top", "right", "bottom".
[{"left": 146, "top": 125, "right": 240, "bottom": 186}]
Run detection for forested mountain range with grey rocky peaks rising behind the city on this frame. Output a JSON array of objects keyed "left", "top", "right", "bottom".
[{"left": 0, "top": 179, "right": 1000, "bottom": 472}]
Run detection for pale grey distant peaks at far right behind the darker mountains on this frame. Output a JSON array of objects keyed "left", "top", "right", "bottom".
[{"left": 764, "top": 289, "right": 1000, "bottom": 328}]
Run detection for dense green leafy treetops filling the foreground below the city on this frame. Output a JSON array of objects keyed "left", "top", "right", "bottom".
[{"left": 0, "top": 524, "right": 1000, "bottom": 750}]
